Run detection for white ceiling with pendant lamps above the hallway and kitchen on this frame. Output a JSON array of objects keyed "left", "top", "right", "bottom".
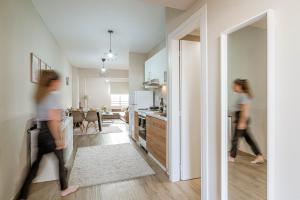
[{"left": 32, "top": 0, "right": 170, "bottom": 69}]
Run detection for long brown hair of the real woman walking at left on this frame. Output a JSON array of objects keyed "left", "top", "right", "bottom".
[{"left": 34, "top": 70, "right": 60, "bottom": 103}]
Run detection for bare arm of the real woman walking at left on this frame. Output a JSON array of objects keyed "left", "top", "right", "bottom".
[{"left": 48, "top": 109, "right": 65, "bottom": 149}]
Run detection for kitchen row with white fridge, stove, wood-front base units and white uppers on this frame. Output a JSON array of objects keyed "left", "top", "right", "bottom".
[{"left": 129, "top": 47, "right": 168, "bottom": 172}]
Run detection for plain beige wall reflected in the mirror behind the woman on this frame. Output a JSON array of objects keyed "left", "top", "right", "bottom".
[{"left": 228, "top": 26, "right": 267, "bottom": 156}]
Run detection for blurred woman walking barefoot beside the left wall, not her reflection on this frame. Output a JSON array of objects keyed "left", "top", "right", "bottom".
[{"left": 18, "top": 70, "right": 78, "bottom": 199}]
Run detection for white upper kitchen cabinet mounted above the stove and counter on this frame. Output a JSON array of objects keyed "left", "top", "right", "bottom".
[{"left": 145, "top": 48, "right": 168, "bottom": 84}]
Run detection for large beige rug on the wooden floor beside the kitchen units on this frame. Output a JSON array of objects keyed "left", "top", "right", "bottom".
[{"left": 69, "top": 144, "right": 155, "bottom": 187}]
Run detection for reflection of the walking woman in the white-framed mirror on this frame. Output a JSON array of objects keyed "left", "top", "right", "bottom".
[{"left": 229, "top": 79, "right": 264, "bottom": 164}]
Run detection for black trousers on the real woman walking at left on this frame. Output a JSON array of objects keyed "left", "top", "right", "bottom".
[{"left": 19, "top": 122, "right": 68, "bottom": 199}]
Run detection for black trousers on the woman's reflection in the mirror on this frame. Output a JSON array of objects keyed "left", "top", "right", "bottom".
[{"left": 230, "top": 112, "right": 261, "bottom": 158}]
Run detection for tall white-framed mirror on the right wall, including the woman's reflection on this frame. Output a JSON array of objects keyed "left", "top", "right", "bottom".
[{"left": 221, "top": 11, "right": 275, "bottom": 200}]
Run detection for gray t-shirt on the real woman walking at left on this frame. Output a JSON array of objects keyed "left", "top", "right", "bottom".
[{"left": 37, "top": 91, "right": 62, "bottom": 121}]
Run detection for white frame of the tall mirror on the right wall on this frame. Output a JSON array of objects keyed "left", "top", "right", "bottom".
[{"left": 221, "top": 10, "right": 276, "bottom": 200}]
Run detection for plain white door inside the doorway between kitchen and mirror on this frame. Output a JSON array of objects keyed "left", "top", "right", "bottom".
[{"left": 180, "top": 41, "right": 201, "bottom": 180}]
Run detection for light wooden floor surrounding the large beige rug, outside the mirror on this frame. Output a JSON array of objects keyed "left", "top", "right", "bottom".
[{"left": 29, "top": 121, "right": 200, "bottom": 200}]
